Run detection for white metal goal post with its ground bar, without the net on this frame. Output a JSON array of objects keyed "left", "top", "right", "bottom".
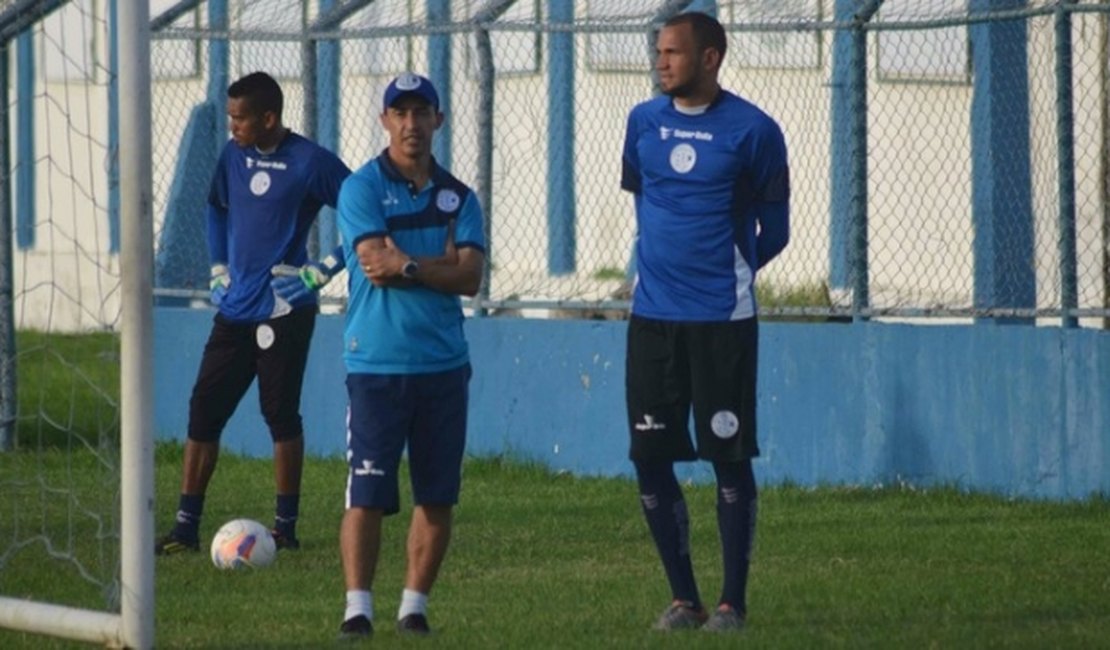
[{"left": 0, "top": 0, "right": 154, "bottom": 649}]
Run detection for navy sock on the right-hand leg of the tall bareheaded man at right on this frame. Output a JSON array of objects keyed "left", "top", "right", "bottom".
[{"left": 713, "top": 459, "right": 757, "bottom": 615}]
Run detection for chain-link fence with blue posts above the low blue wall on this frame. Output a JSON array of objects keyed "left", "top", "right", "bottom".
[{"left": 152, "top": 0, "right": 1110, "bottom": 325}]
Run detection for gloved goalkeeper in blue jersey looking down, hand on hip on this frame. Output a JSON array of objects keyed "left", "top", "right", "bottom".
[{"left": 154, "top": 72, "right": 351, "bottom": 555}]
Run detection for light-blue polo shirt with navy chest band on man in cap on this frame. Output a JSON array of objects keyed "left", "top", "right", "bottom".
[{"left": 339, "top": 151, "right": 485, "bottom": 375}]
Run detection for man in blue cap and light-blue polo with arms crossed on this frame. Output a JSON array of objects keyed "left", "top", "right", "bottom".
[{"left": 330, "top": 73, "right": 485, "bottom": 638}]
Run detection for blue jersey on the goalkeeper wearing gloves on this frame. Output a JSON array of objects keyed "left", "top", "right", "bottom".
[{"left": 208, "top": 131, "right": 351, "bottom": 323}]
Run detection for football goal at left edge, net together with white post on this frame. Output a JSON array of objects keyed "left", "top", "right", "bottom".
[{"left": 0, "top": 0, "right": 153, "bottom": 648}]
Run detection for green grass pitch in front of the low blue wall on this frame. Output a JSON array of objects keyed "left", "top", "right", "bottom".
[{"left": 0, "top": 445, "right": 1110, "bottom": 649}]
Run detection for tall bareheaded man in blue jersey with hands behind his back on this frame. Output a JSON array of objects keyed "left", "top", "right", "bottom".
[{"left": 620, "top": 12, "right": 789, "bottom": 631}]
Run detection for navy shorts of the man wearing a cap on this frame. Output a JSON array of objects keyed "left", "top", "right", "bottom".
[{"left": 346, "top": 364, "right": 471, "bottom": 515}]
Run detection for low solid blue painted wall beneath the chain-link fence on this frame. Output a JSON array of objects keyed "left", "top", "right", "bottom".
[{"left": 154, "top": 307, "right": 1110, "bottom": 499}]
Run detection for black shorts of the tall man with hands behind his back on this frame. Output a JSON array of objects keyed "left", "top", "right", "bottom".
[{"left": 625, "top": 316, "right": 759, "bottom": 461}]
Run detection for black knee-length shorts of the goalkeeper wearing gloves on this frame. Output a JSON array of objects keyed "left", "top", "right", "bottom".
[{"left": 189, "top": 305, "right": 316, "bottom": 441}]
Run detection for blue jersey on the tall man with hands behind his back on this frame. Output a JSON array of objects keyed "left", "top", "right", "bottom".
[{"left": 620, "top": 90, "right": 790, "bottom": 321}]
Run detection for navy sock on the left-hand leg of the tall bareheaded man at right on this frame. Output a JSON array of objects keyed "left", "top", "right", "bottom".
[{"left": 634, "top": 461, "right": 702, "bottom": 609}]
